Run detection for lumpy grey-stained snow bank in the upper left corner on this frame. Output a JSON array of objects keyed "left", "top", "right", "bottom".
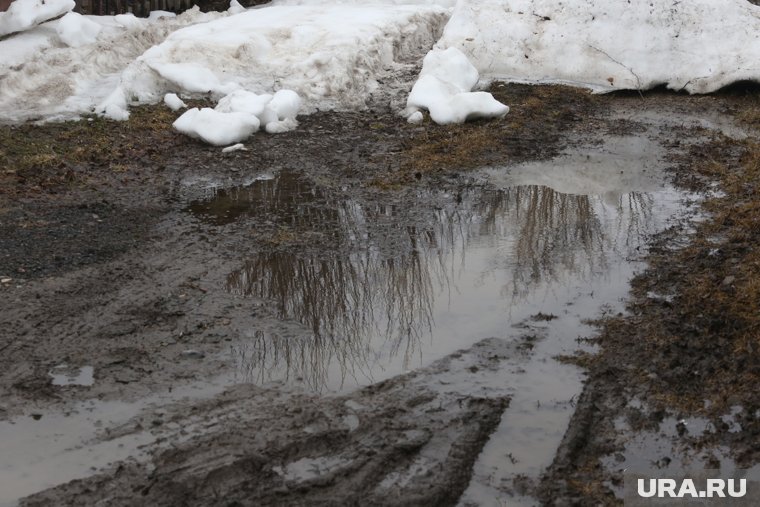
[{"left": 0, "top": 7, "right": 225, "bottom": 122}]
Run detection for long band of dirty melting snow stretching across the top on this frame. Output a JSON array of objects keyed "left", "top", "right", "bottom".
[{"left": 0, "top": 0, "right": 760, "bottom": 122}]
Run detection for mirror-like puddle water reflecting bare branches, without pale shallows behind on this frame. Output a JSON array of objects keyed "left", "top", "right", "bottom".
[{"left": 192, "top": 165, "right": 676, "bottom": 390}]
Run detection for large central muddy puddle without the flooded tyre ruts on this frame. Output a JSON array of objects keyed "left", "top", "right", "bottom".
[{"left": 187, "top": 137, "right": 692, "bottom": 393}]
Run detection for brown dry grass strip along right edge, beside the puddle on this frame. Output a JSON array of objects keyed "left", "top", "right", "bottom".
[{"left": 600, "top": 133, "right": 760, "bottom": 415}]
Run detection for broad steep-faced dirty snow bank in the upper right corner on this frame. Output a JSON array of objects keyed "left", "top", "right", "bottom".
[{"left": 437, "top": 0, "right": 760, "bottom": 93}]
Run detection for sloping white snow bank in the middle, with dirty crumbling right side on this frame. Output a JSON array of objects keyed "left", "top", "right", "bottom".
[{"left": 109, "top": 4, "right": 449, "bottom": 111}]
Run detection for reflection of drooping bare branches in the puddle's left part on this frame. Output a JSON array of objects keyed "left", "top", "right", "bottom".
[{"left": 228, "top": 250, "right": 435, "bottom": 389}]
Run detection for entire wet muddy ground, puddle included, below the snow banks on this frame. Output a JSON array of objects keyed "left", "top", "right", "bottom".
[{"left": 0, "top": 83, "right": 760, "bottom": 505}]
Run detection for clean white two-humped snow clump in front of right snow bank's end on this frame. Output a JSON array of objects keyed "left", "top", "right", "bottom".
[{"left": 407, "top": 48, "right": 509, "bottom": 124}]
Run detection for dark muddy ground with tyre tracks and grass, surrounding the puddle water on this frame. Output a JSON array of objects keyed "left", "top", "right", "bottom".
[{"left": 0, "top": 83, "right": 760, "bottom": 505}]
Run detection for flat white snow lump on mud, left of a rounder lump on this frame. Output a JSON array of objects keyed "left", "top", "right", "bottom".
[{"left": 173, "top": 107, "right": 259, "bottom": 146}]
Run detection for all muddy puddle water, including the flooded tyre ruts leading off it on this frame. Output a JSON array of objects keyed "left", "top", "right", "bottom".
[{"left": 0, "top": 136, "right": 694, "bottom": 505}]
